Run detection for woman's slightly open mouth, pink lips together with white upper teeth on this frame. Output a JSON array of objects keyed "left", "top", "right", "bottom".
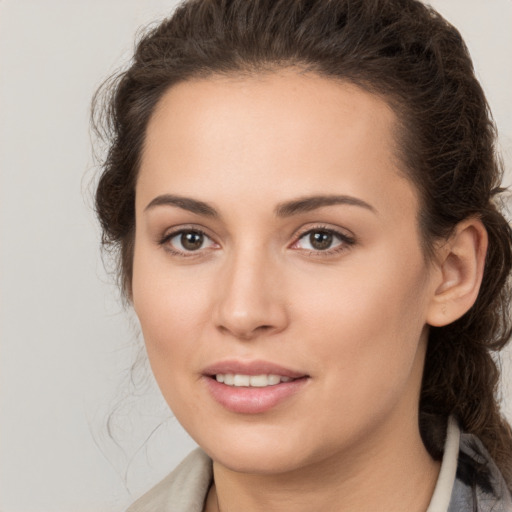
[{"left": 203, "top": 361, "right": 310, "bottom": 414}]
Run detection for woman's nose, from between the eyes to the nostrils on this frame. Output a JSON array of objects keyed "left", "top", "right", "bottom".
[{"left": 213, "top": 251, "right": 288, "bottom": 340}]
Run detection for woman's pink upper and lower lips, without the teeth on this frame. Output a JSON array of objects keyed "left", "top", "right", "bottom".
[{"left": 202, "top": 361, "right": 309, "bottom": 414}]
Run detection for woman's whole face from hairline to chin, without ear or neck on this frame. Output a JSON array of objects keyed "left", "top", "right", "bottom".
[{"left": 133, "top": 70, "right": 435, "bottom": 472}]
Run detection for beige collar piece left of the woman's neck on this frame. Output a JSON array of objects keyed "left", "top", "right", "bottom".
[{"left": 126, "top": 448, "right": 212, "bottom": 512}]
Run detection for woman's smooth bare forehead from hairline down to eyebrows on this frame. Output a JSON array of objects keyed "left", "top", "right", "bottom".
[{"left": 137, "top": 70, "right": 411, "bottom": 217}]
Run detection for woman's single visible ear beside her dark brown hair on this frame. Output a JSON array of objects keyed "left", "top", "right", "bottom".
[{"left": 427, "top": 218, "right": 488, "bottom": 327}]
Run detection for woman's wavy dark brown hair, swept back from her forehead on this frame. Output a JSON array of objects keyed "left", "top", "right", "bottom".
[{"left": 92, "top": 0, "right": 512, "bottom": 486}]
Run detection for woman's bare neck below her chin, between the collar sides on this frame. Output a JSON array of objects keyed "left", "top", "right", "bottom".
[{"left": 205, "top": 412, "right": 440, "bottom": 512}]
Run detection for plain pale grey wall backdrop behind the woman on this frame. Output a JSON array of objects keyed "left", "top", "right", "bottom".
[{"left": 0, "top": 0, "right": 512, "bottom": 512}]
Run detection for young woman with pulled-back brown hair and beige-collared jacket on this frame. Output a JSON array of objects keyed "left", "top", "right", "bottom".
[{"left": 93, "top": 0, "right": 512, "bottom": 512}]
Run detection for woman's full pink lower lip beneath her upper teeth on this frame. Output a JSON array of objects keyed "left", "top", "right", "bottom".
[{"left": 204, "top": 377, "right": 309, "bottom": 414}]
